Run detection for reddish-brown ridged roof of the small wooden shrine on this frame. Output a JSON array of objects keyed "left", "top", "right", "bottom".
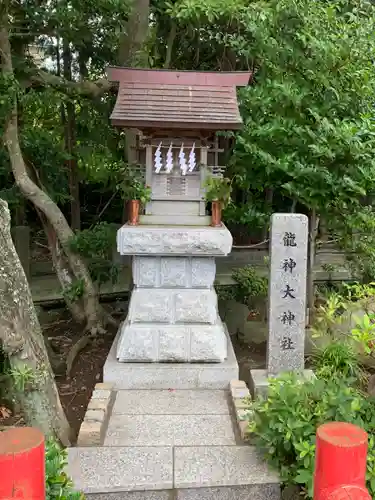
[{"left": 108, "top": 67, "right": 251, "bottom": 131}]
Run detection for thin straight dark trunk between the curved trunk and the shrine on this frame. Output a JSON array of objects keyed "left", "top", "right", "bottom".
[{"left": 62, "top": 40, "right": 81, "bottom": 231}]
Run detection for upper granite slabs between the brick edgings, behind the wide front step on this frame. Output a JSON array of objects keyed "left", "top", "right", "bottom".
[{"left": 103, "top": 389, "right": 236, "bottom": 446}]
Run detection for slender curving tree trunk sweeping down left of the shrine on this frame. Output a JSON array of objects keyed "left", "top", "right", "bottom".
[{"left": 0, "top": 9, "right": 105, "bottom": 334}]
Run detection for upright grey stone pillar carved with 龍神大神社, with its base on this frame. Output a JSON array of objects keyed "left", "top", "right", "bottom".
[{"left": 250, "top": 214, "right": 313, "bottom": 395}]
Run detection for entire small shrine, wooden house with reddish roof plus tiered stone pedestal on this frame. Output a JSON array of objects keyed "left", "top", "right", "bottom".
[{"left": 109, "top": 68, "right": 250, "bottom": 364}]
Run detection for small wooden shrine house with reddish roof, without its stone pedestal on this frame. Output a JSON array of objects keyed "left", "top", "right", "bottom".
[{"left": 108, "top": 67, "right": 250, "bottom": 224}]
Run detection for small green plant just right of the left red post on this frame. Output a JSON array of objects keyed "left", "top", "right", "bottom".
[{"left": 45, "top": 440, "right": 85, "bottom": 500}]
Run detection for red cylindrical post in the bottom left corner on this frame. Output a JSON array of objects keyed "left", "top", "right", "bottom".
[{"left": 0, "top": 427, "right": 46, "bottom": 500}]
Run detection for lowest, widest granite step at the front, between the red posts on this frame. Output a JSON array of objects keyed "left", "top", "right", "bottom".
[{"left": 68, "top": 446, "right": 281, "bottom": 500}]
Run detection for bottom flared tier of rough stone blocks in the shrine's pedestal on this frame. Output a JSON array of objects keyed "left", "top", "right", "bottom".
[{"left": 117, "top": 321, "right": 227, "bottom": 363}]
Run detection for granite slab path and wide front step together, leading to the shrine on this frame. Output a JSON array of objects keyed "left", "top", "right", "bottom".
[{"left": 69, "top": 389, "right": 280, "bottom": 500}]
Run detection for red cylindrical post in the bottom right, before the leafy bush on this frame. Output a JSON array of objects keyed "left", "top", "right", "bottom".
[{"left": 314, "top": 422, "right": 370, "bottom": 500}]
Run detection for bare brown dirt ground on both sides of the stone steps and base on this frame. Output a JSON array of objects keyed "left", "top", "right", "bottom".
[{"left": 0, "top": 303, "right": 266, "bottom": 437}]
